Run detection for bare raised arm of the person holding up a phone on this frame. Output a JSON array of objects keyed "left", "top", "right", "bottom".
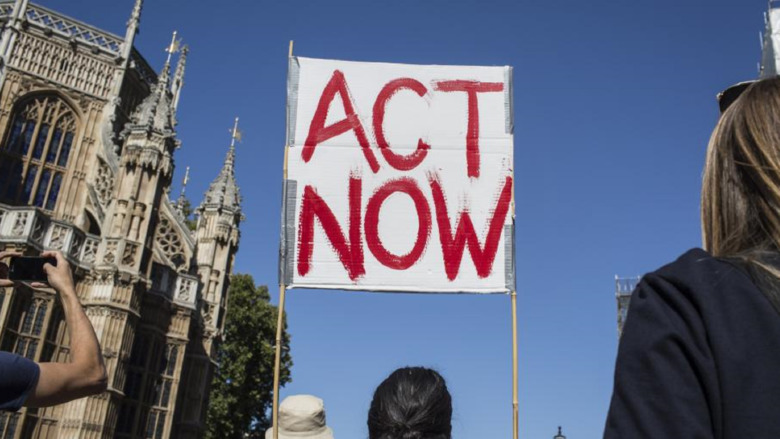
[{"left": 24, "top": 252, "right": 107, "bottom": 407}]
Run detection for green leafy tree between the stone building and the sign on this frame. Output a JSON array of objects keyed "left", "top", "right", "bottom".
[{"left": 206, "top": 274, "right": 292, "bottom": 439}]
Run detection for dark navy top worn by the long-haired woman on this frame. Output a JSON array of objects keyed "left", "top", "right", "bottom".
[{"left": 604, "top": 249, "right": 780, "bottom": 439}]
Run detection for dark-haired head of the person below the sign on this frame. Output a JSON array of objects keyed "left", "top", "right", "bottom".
[{"left": 368, "top": 367, "right": 452, "bottom": 439}]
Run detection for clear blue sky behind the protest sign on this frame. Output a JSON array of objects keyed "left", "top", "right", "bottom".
[{"left": 43, "top": 0, "right": 766, "bottom": 439}]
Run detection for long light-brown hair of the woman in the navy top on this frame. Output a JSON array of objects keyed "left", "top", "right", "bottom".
[{"left": 701, "top": 77, "right": 780, "bottom": 264}]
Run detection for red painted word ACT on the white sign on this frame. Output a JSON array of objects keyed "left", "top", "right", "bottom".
[{"left": 301, "top": 70, "right": 504, "bottom": 177}]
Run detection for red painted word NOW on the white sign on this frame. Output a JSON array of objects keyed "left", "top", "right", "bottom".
[{"left": 298, "top": 175, "right": 512, "bottom": 281}]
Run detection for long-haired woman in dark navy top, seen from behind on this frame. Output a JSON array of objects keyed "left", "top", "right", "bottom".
[{"left": 604, "top": 78, "right": 780, "bottom": 439}]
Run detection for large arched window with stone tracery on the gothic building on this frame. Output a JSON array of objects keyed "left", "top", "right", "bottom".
[{"left": 0, "top": 95, "right": 76, "bottom": 210}]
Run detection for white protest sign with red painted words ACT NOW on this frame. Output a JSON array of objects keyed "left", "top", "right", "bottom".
[{"left": 280, "top": 57, "right": 514, "bottom": 293}]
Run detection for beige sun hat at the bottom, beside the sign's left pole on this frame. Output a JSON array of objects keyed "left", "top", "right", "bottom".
[{"left": 265, "top": 395, "right": 333, "bottom": 439}]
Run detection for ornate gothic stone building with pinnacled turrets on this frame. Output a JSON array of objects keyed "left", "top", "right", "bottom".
[{"left": 0, "top": 0, "right": 241, "bottom": 439}]
